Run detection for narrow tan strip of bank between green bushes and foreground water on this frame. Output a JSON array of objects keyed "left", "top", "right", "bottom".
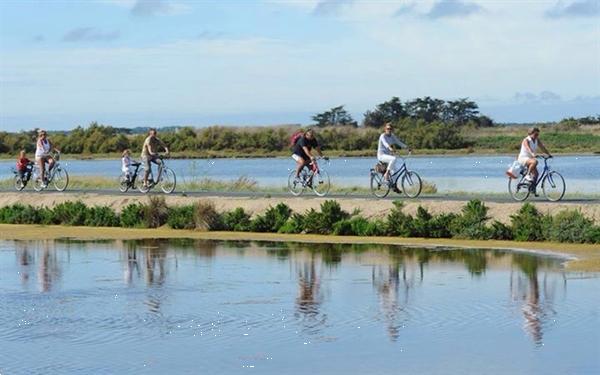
[{"left": 0, "top": 224, "right": 600, "bottom": 272}]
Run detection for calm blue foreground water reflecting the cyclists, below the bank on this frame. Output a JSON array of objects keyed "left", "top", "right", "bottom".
[{"left": 0, "top": 240, "right": 600, "bottom": 374}]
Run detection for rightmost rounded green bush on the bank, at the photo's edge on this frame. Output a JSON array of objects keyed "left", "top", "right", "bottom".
[{"left": 544, "top": 210, "right": 598, "bottom": 243}]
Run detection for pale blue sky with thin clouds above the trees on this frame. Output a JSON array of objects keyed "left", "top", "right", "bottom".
[{"left": 0, "top": 0, "right": 600, "bottom": 130}]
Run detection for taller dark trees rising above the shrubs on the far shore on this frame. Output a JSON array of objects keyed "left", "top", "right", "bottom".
[{"left": 312, "top": 96, "right": 494, "bottom": 128}]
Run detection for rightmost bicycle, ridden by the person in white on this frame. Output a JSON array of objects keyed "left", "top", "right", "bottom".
[{"left": 508, "top": 156, "right": 567, "bottom": 202}]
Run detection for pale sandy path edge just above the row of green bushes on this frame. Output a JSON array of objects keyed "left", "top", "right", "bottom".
[{"left": 0, "top": 192, "right": 600, "bottom": 223}]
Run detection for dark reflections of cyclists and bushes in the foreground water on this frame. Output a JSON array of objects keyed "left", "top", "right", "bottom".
[{"left": 7, "top": 239, "right": 566, "bottom": 345}]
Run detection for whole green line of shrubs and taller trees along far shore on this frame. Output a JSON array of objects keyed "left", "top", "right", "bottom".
[{"left": 0, "top": 97, "right": 600, "bottom": 156}]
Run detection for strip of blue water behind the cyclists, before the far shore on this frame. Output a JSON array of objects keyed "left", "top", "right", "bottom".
[{"left": 0, "top": 155, "right": 600, "bottom": 194}]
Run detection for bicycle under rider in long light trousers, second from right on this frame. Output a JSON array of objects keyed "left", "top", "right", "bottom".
[{"left": 370, "top": 152, "right": 423, "bottom": 198}]
